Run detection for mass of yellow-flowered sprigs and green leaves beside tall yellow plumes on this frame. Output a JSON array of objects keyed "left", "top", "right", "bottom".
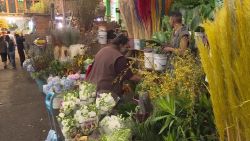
[{"left": 132, "top": 53, "right": 218, "bottom": 141}]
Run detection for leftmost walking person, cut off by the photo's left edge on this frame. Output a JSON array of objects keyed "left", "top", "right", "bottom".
[{"left": 0, "top": 36, "right": 7, "bottom": 69}]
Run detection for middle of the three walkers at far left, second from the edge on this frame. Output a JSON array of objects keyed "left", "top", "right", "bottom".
[{"left": 5, "top": 35, "right": 16, "bottom": 69}]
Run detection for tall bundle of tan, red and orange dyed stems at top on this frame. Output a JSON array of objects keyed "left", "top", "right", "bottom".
[{"left": 119, "top": 0, "right": 173, "bottom": 39}]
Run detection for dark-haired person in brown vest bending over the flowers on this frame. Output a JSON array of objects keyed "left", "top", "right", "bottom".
[{"left": 87, "top": 34, "right": 140, "bottom": 98}]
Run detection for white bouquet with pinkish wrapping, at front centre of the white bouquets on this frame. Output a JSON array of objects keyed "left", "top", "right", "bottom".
[{"left": 74, "top": 105, "right": 98, "bottom": 135}]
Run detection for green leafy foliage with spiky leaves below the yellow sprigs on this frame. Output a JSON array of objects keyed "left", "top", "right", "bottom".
[{"left": 133, "top": 94, "right": 217, "bottom": 141}]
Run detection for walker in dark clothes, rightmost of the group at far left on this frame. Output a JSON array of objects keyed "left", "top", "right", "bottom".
[{"left": 15, "top": 34, "right": 25, "bottom": 67}]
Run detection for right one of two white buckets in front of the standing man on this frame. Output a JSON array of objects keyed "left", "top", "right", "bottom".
[{"left": 154, "top": 54, "right": 167, "bottom": 71}]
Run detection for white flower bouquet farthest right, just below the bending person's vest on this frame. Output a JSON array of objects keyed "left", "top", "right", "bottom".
[{"left": 96, "top": 93, "right": 116, "bottom": 115}]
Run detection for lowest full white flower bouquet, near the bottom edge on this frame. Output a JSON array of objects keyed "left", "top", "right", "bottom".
[{"left": 99, "top": 115, "right": 124, "bottom": 135}]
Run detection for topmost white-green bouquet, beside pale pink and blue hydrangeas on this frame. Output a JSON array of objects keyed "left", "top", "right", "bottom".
[{"left": 79, "top": 82, "right": 96, "bottom": 105}]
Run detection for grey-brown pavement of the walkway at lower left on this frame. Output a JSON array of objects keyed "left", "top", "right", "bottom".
[{"left": 0, "top": 57, "right": 49, "bottom": 141}]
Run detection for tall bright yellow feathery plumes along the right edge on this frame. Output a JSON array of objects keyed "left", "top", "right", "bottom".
[{"left": 198, "top": 0, "right": 250, "bottom": 141}]
